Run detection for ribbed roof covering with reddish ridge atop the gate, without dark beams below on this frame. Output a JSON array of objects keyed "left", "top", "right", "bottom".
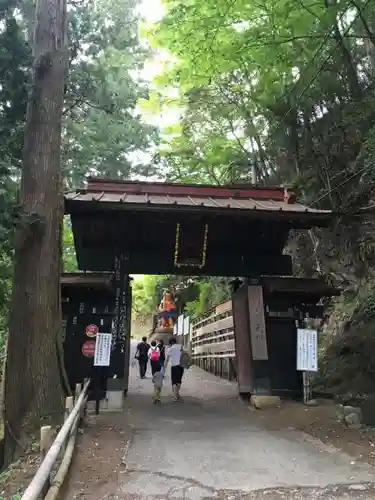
[{"left": 65, "top": 178, "right": 331, "bottom": 221}]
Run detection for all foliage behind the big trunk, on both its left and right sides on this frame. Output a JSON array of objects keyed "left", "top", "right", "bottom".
[{"left": 0, "top": 0, "right": 157, "bottom": 362}]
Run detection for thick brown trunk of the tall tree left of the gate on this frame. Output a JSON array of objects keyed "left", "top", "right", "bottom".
[{"left": 4, "top": 0, "right": 68, "bottom": 462}]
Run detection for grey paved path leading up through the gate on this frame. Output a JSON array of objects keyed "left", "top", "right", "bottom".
[{"left": 69, "top": 340, "right": 375, "bottom": 500}]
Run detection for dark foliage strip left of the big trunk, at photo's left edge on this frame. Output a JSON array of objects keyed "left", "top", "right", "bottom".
[{"left": 0, "top": 0, "right": 30, "bottom": 348}]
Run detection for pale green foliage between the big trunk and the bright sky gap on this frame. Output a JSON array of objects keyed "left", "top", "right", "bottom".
[{"left": 63, "top": 0, "right": 157, "bottom": 187}]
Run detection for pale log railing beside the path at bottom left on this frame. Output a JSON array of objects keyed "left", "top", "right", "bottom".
[{"left": 21, "top": 380, "right": 90, "bottom": 500}]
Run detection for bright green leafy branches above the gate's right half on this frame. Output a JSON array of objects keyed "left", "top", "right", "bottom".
[{"left": 150, "top": 0, "right": 375, "bottom": 208}]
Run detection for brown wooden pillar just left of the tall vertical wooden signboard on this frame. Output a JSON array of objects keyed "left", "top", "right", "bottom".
[{"left": 232, "top": 283, "right": 253, "bottom": 395}]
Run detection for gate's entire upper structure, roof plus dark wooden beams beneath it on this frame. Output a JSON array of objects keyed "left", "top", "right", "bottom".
[{"left": 65, "top": 178, "right": 333, "bottom": 276}]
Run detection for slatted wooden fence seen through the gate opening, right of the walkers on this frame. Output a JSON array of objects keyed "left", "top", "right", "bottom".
[{"left": 191, "top": 300, "right": 236, "bottom": 380}]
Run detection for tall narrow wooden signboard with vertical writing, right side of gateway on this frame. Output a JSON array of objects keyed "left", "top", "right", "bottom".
[{"left": 248, "top": 285, "right": 268, "bottom": 361}]
